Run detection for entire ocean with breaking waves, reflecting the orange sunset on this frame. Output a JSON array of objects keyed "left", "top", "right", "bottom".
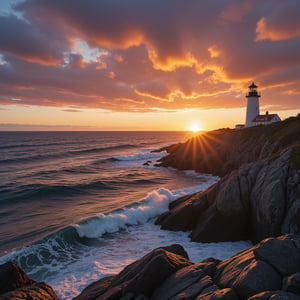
[{"left": 0, "top": 132, "right": 251, "bottom": 299}]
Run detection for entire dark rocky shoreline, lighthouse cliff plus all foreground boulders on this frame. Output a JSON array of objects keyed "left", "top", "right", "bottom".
[{"left": 0, "top": 117, "right": 300, "bottom": 300}]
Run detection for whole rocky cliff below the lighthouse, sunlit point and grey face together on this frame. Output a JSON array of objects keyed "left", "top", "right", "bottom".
[{"left": 156, "top": 118, "right": 300, "bottom": 242}]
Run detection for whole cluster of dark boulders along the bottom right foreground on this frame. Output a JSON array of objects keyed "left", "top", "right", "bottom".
[{"left": 75, "top": 234, "right": 300, "bottom": 300}]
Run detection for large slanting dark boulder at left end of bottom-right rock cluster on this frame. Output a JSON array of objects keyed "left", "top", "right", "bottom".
[{"left": 75, "top": 244, "right": 192, "bottom": 300}]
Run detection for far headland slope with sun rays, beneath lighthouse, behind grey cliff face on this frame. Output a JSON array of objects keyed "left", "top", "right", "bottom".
[{"left": 157, "top": 117, "right": 300, "bottom": 177}]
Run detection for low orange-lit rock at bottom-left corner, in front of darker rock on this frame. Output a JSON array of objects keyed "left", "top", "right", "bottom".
[{"left": 0, "top": 282, "right": 58, "bottom": 300}]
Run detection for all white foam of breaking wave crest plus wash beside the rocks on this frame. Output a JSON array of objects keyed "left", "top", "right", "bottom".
[{"left": 1, "top": 177, "right": 251, "bottom": 300}]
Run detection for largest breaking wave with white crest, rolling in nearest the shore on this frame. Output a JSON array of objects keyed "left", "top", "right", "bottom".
[{"left": 0, "top": 178, "right": 218, "bottom": 292}]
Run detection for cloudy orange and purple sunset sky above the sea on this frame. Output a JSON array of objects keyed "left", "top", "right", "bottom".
[{"left": 0, "top": 0, "right": 300, "bottom": 130}]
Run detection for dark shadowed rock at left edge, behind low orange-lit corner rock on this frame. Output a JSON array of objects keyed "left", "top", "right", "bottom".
[{"left": 0, "top": 262, "right": 34, "bottom": 294}]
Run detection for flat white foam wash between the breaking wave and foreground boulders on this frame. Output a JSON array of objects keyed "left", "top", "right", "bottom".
[{"left": 48, "top": 222, "right": 251, "bottom": 299}]
